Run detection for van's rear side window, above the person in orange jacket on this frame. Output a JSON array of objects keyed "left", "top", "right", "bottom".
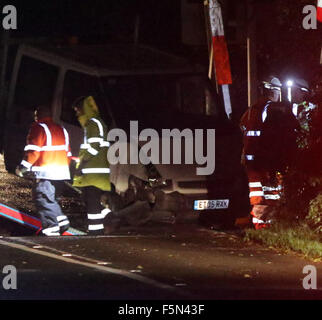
[{"left": 9, "top": 56, "right": 58, "bottom": 125}]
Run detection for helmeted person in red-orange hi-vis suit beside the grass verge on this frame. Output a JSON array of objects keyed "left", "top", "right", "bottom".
[{"left": 240, "top": 77, "right": 282, "bottom": 229}]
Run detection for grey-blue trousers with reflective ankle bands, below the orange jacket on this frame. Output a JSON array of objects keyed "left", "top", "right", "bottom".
[{"left": 32, "top": 179, "right": 69, "bottom": 236}]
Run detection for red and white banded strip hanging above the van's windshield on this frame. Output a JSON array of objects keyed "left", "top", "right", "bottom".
[{"left": 209, "top": 0, "right": 232, "bottom": 116}]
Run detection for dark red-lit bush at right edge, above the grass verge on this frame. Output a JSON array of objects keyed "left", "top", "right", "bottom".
[{"left": 279, "top": 102, "right": 322, "bottom": 231}]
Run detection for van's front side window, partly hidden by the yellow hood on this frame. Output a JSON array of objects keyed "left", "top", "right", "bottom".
[{"left": 60, "top": 71, "right": 101, "bottom": 126}]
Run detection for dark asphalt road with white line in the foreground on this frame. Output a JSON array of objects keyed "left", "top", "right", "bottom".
[{"left": 0, "top": 225, "right": 322, "bottom": 300}]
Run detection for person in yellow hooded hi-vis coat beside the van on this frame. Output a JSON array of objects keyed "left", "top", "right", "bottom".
[{"left": 73, "top": 96, "right": 111, "bottom": 235}]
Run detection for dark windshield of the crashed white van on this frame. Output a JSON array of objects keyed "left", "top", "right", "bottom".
[{"left": 101, "top": 75, "right": 223, "bottom": 127}]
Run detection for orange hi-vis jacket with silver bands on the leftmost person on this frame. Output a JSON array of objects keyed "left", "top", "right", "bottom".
[{"left": 21, "top": 118, "right": 71, "bottom": 180}]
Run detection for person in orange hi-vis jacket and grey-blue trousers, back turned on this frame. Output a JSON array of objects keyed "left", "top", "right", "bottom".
[{"left": 16, "top": 105, "right": 71, "bottom": 236}]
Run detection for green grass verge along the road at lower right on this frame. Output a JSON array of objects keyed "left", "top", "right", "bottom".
[{"left": 244, "top": 223, "right": 322, "bottom": 262}]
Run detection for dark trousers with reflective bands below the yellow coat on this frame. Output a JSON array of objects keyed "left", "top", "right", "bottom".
[{"left": 82, "top": 186, "right": 105, "bottom": 235}]
